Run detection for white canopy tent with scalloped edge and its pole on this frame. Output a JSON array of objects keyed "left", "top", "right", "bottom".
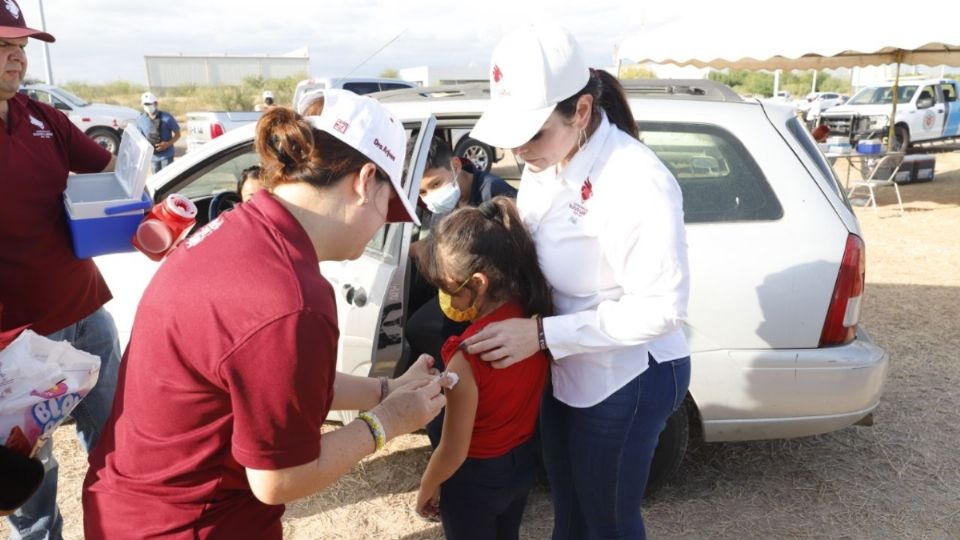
[{"left": 617, "top": 10, "right": 960, "bottom": 150}]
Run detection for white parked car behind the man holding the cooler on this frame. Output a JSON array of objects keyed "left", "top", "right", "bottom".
[{"left": 20, "top": 84, "right": 140, "bottom": 154}]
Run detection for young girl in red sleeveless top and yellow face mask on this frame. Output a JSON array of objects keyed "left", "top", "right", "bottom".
[{"left": 417, "top": 197, "right": 553, "bottom": 540}]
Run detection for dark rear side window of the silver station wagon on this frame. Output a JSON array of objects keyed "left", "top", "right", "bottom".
[{"left": 640, "top": 122, "right": 783, "bottom": 223}]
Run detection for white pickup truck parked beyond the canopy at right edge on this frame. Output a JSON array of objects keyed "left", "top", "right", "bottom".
[{"left": 819, "top": 79, "right": 960, "bottom": 149}]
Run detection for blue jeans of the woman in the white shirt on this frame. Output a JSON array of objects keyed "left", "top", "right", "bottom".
[{"left": 540, "top": 357, "right": 690, "bottom": 540}]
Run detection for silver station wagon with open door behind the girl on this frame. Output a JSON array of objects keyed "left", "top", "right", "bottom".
[{"left": 97, "top": 80, "right": 888, "bottom": 489}]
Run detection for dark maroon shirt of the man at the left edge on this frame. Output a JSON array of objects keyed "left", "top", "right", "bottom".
[{"left": 0, "top": 94, "right": 110, "bottom": 335}]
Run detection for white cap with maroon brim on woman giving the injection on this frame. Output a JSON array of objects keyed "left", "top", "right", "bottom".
[{"left": 304, "top": 90, "right": 420, "bottom": 225}]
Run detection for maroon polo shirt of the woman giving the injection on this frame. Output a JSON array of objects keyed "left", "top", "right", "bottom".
[{"left": 83, "top": 191, "right": 339, "bottom": 539}]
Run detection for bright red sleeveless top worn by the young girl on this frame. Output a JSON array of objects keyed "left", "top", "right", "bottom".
[{"left": 441, "top": 302, "right": 550, "bottom": 458}]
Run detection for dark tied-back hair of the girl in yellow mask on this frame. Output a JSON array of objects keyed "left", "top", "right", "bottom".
[{"left": 417, "top": 196, "right": 553, "bottom": 316}]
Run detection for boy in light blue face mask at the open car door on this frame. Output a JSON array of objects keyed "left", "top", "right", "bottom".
[{"left": 420, "top": 137, "right": 517, "bottom": 215}]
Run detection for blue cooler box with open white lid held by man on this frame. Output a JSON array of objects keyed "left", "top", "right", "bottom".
[{"left": 63, "top": 127, "right": 153, "bottom": 259}]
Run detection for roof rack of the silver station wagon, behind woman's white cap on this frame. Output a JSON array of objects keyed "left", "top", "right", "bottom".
[{"left": 370, "top": 79, "right": 743, "bottom": 102}]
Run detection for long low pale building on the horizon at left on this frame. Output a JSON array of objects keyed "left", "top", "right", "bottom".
[{"left": 143, "top": 47, "right": 310, "bottom": 89}]
